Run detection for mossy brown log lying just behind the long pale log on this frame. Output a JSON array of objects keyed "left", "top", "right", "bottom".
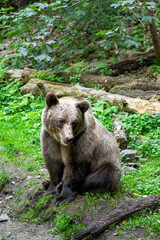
[{"left": 8, "top": 68, "right": 160, "bottom": 100}]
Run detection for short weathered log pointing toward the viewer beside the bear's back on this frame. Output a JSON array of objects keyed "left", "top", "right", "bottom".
[{"left": 113, "top": 115, "right": 127, "bottom": 149}]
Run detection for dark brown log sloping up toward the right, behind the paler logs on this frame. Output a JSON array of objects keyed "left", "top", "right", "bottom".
[{"left": 92, "top": 50, "right": 156, "bottom": 76}]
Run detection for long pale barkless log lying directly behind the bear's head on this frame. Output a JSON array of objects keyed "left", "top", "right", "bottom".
[{"left": 21, "top": 79, "right": 160, "bottom": 113}]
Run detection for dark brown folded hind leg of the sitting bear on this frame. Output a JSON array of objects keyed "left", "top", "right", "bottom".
[{"left": 81, "top": 163, "right": 121, "bottom": 193}]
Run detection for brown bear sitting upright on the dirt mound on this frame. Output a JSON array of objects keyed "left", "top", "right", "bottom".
[{"left": 41, "top": 93, "right": 121, "bottom": 204}]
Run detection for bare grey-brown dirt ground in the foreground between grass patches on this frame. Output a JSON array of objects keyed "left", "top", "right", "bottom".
[{"left": 0, "top": 163, "right": 160, "bottom": 240}]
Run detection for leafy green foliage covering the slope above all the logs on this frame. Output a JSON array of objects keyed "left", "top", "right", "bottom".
[{"left": 0, "top": 0, "right": 160, "bottom": 71}]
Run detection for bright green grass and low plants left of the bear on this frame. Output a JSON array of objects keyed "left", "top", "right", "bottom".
[{"left": 0, "top": 80, "right": 45, "bottom": 171}]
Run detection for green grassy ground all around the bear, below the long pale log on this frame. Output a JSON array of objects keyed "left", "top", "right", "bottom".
[{"left": 0, "top": 80, "right": 160, "bottom": 239}]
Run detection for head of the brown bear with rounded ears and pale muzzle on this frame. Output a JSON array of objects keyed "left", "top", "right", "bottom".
[{"left": 42, "top": 93, "right": 90, "bottom": 147}]
